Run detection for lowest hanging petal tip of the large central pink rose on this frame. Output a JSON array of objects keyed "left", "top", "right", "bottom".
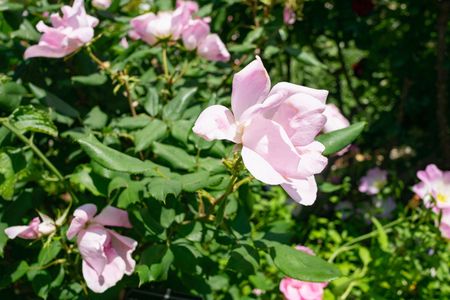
[{"left": 281, "top": 176, "right": 317, "bottom": 205}]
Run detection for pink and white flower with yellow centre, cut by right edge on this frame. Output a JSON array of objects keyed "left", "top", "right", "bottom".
[{"left": 413, "top": 164, "right": 450, "bottom": 239}]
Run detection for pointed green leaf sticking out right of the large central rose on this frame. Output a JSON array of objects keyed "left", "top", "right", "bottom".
[{"left": 316, "top": 122, "right": 366, "bottom": 155}]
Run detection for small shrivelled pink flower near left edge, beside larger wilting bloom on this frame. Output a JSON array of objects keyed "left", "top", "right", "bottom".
[{"left": 5, "top": 213, "right": 56, "bottom": 240}]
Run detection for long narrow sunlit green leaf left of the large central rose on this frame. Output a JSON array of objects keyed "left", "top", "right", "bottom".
[{"left": 78, "top": 135, "right": 155, "bottom": 174}]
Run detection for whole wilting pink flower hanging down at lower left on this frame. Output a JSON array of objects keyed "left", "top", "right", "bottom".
[{"left": 67, "top": 204, "right": 137, "bottom": 293}]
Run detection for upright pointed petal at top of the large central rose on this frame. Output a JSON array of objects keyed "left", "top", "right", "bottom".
[{"left": 231, "top": 57, "right": 270, "bottom": 120}]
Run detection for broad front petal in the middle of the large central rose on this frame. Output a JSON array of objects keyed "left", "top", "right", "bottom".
[{"left": 242, "top": 117, "right": 301, "bottom": 179}]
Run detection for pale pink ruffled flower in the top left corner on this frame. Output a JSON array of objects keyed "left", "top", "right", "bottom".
[{"left": 24, "top": 0, "right": 98, "bottom": 59}]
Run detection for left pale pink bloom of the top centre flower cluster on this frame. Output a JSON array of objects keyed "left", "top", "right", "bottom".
[{"left": 129, "top": 3, "right": 192, "bottom": 45}]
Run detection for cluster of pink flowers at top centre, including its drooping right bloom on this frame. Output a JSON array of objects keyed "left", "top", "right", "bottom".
[{"left": 129, "top": 0, "right": 230, "bottom": 61}]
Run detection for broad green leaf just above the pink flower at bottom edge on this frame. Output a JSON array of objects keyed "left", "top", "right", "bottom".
[{"left": 270, "top": 242, "right": 341, "bottom": 282}]
